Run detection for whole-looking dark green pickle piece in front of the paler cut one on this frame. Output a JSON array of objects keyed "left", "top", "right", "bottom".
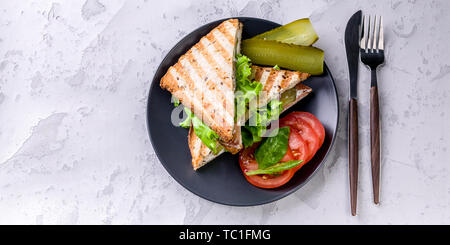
[{"left": 241, "top": 38, "right": 324, "bottom": 75}]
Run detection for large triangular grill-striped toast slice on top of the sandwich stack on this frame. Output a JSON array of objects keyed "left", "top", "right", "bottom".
[{"left": 160, "top": 19, "right": 242, "bottom": 145}]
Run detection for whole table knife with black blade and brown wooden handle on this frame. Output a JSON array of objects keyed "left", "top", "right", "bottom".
[{"left": 345, "top": 10, "right": 362, "bottom": 216}]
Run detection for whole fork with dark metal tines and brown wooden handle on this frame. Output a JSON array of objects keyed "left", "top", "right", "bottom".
[{"left": 360, "top": 15, "right": 384, "bottom": 204}]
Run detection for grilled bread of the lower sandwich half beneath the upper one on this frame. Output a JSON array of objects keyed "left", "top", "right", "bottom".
[{"left": 188, "top": 66, "right": 312, "bottom": 170}]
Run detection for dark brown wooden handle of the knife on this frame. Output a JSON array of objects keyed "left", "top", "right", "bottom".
[{"left": 348, "top": 98, "right": 358, "bottom": 216}]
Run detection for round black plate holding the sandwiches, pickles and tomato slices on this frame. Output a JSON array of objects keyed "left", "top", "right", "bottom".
[{"left": 147, "top": 17, "right": 339, "bottom": 206}]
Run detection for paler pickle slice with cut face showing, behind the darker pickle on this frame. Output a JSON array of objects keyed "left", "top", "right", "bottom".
[{"left": 253, "top": 19, "right": 319, "bottom": 46}]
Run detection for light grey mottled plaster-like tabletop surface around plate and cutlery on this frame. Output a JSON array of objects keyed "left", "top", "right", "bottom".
[{"left": 0, "top": 0, "right": 450, "bottom": 224}]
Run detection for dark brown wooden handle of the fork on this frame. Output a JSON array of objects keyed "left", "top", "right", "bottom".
[{"left": 370, "top": 86, "right": 380, "bottom": 204}]
